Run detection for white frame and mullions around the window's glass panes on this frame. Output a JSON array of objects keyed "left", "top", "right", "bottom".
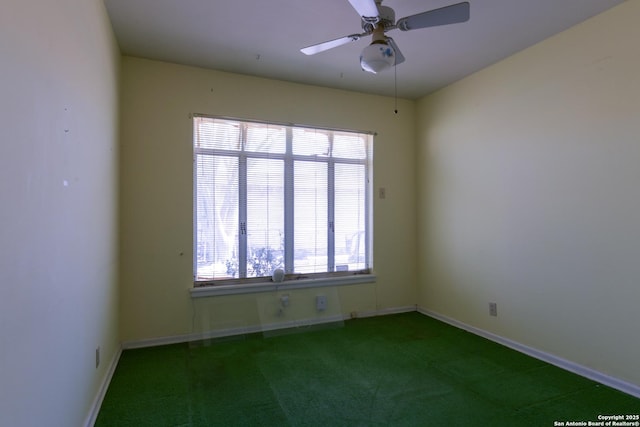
[{"left": 191, "top": 114, "right": 375, "bottom": 297}]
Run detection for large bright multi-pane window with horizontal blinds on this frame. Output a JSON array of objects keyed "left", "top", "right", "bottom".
[{"left": 193, "top": 116, "right": 373, "bottom": 286}]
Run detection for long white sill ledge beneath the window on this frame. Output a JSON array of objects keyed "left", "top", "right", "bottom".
[{"left": 189, "top": 274, "right": 376, "bottom": 298}]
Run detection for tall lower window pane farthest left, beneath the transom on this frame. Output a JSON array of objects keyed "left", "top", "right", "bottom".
[{"left": 196, "top": 155, "right": 238, "bottom": 280}]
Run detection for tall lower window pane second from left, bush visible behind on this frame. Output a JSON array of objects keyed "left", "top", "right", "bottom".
[{"left": 247, "top": 159, "right": 284, "bottom": 277}]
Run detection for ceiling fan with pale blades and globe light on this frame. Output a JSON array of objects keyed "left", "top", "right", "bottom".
[{"left": 300, "top": 0, "right": 469, "bottom": 73}]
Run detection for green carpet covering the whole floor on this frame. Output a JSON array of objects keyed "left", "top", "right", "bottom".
[{"left": 96, "top": 312, "right": 640, "bottom": 426}]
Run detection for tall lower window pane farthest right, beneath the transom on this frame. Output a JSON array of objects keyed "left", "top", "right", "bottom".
[{"left": 334, "top": 164, "right": 367, "bottom": 271}]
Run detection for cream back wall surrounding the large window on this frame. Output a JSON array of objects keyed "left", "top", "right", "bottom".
[{"left": 121, "top": 57, "right": 417, "bottom": 342}]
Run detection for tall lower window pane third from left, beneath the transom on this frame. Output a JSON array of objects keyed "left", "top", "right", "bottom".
[{"left": 293, "top": 161, "right": 328, "bottom": 273}]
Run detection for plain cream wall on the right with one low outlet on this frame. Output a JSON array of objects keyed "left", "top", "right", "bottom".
[{"left": 417, "top": 1, "right": 640, "bottom": 384}]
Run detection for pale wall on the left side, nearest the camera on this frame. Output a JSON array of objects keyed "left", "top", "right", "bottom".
[{"left": 0, "top": 0, "right": 120, "bottom": 427}]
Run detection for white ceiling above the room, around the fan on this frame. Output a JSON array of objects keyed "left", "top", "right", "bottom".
[{"left": 105, "top": 0, "right": 625, "bottom": 99}]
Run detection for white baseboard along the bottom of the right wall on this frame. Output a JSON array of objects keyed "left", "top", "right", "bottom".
[{"left": 417, "top": 308, "right": 640, "bottom": 398}]
